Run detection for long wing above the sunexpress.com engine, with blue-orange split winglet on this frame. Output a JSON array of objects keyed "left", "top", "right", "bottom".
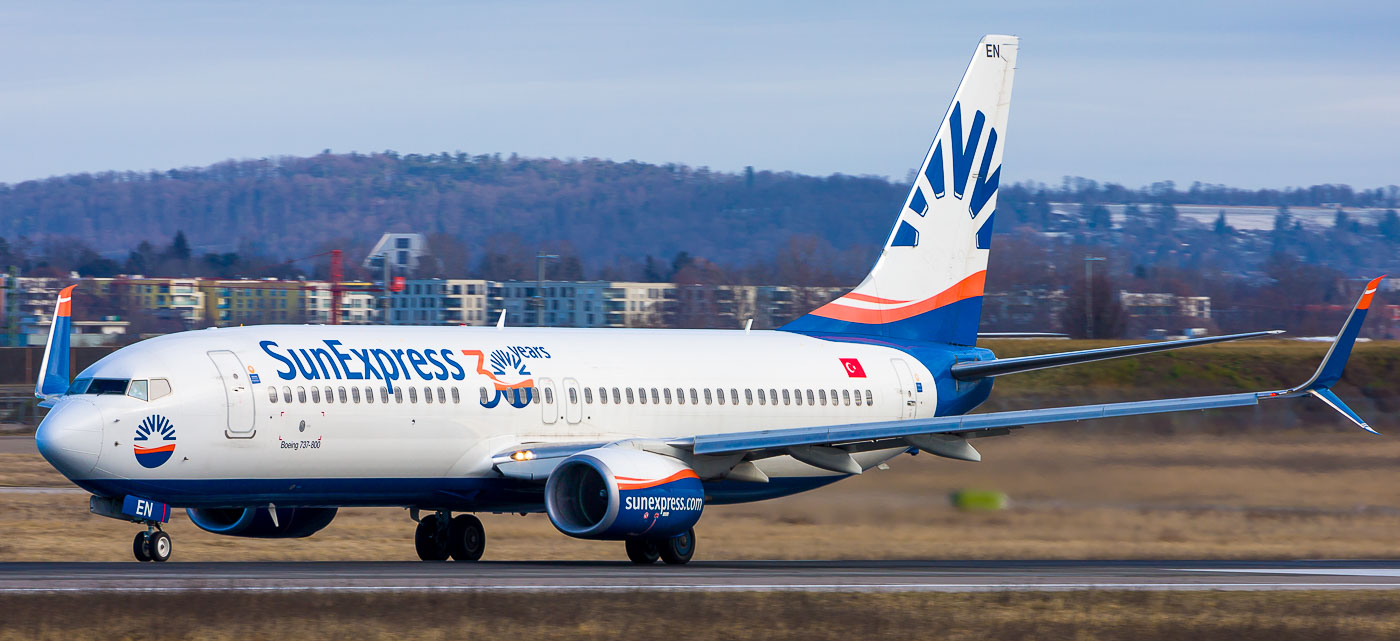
[{"left": 496, "top": 279, "right": 1380, "bottom": 480}]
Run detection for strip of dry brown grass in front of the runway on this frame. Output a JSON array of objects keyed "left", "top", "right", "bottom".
[{"left": 8, "top": 592, "right": 1400, "bottom": 641}]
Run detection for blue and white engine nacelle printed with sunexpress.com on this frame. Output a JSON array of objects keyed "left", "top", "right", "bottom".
[{"left": 545, "top": 448, "right": 704, "bottom": 540}]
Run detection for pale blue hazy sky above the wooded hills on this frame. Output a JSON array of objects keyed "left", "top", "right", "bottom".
[{"left": 0, "top": 0, "right": 1400, "bottom": 188}]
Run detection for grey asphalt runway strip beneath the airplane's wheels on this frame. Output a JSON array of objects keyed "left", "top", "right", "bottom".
[{"left": 0, "top": 561, "right": 1400, "bottom": 595}]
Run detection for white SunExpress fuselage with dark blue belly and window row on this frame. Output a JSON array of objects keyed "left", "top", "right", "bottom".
[{"left": 39, "top": 326, "right": 937, "bottom": 511}]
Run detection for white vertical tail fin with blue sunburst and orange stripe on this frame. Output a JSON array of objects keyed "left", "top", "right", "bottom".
[{"left": 781, "top": 35, "right": 1019, "bottom": 344}]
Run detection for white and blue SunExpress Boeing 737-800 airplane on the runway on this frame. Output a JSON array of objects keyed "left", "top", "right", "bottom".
[{"left": 35, "top": 35, "right": 1380, "bottom": 565}]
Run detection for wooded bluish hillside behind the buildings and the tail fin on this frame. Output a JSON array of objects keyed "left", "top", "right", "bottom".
[{"left": 0, "top": 151, "right": 1400, "bottom": 338}]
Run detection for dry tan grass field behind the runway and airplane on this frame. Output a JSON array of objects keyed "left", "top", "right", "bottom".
[{"left": 0, "top": 425, "right": 1400, "bottom": 561}]
